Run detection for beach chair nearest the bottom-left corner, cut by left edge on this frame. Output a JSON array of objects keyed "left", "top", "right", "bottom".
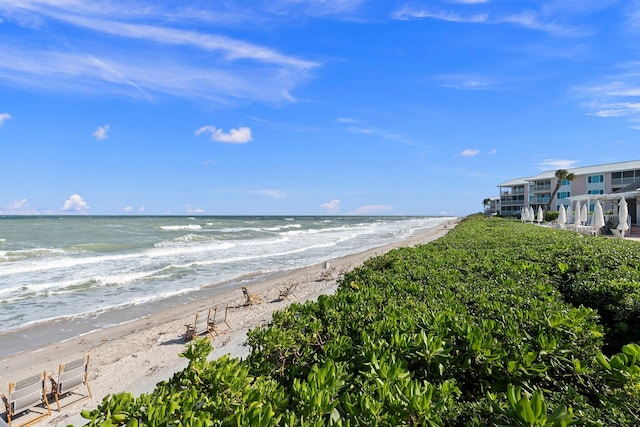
[{"left": 0, "top": 372, "right": 51, "bottom": 427}]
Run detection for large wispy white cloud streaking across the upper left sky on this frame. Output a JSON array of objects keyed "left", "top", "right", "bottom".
[{"left": 0, "top": 0, "right": 319, "bottom": 103}]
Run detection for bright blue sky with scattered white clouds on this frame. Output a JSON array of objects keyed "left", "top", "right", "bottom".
[{"left": 0, "top": 0, "right": 640, "bottom": 216}]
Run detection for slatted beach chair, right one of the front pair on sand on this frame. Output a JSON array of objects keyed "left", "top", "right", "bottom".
[{"left": 49, "top": 355, "right": 93, "bottom": 412}]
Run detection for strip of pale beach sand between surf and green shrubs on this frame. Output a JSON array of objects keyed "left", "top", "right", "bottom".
[{"left": 0, "top": 219, "right": 459, "bottom": 426}]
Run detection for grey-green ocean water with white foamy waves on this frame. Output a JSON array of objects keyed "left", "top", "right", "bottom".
[{"left": 0, "top": 216, "right": 449, "bottom": 356}]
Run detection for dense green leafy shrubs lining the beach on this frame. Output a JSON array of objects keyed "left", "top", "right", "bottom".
[{"left": 84, "top": 216, "right": 640, "bottom": 426}]
